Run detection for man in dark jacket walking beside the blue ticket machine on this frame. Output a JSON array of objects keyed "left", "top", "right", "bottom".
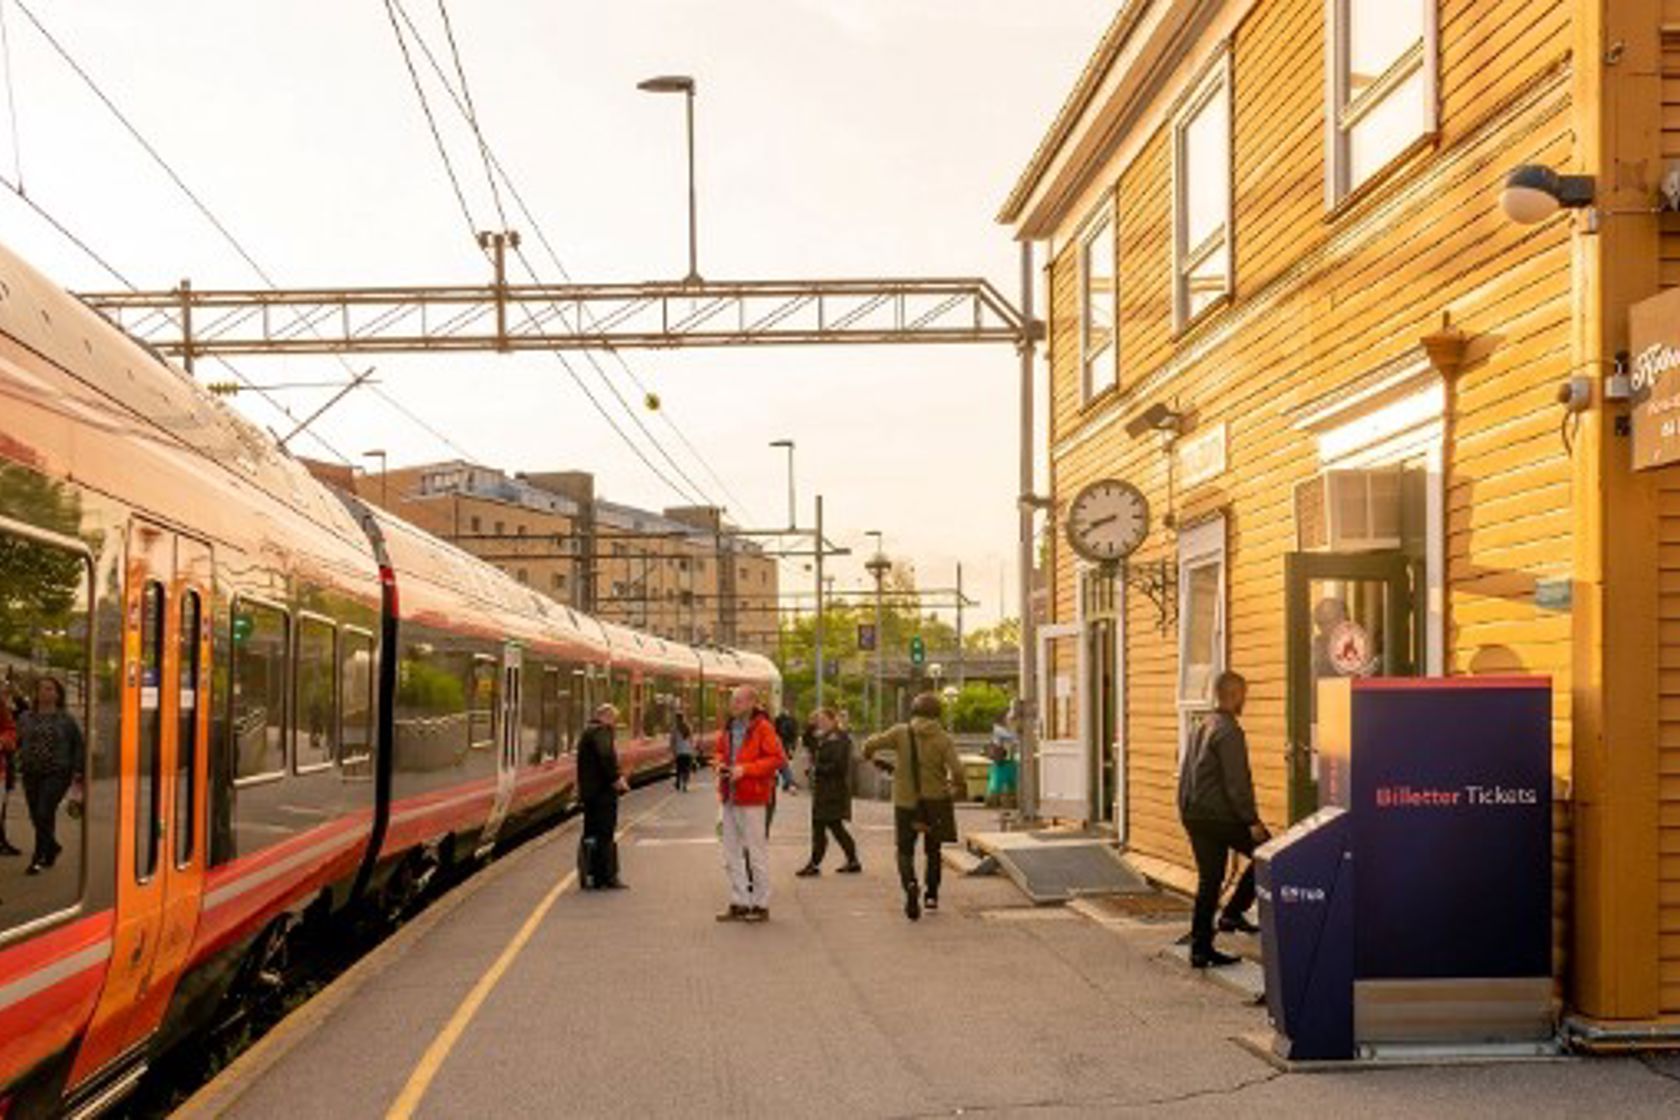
[{"left": 1178, "top": 670, "right": 1270, "bottom": 969}]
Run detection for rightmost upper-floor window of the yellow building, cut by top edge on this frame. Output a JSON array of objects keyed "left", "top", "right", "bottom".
[{"left": 1326, "top": 0, "right": 1436, "bottom": 207}]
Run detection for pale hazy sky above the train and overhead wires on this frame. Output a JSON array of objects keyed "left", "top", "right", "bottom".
[{"left": 0, "top": 0, "right": 1116, "bottom": 625}]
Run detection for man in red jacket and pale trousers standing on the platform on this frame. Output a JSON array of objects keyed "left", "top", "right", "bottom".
[{"left": 712, "top": 685, "right": 788, "bottom": 922}]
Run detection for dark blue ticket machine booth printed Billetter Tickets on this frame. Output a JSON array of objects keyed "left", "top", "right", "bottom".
[{"left": 1257, "top": 677, "right": 1556, "bottom": 1056}]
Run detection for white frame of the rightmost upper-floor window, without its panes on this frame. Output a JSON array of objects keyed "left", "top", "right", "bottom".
[{"left": 1324, "top": 0, "right": 1440, "bottom": 210}]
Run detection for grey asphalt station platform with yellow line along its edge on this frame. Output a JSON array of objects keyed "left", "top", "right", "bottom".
[{"left": 181, "top": 788, "right": 1680, "bottom": 1120}]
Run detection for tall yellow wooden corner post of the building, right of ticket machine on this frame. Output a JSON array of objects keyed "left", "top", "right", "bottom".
[{"left": 1569, "top": 0, "right": 1662, "bottom": 1019}]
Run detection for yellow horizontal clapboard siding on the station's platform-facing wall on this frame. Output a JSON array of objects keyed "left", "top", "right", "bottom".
[{"left": 1050, "top": 0, "right": 1579, "bottom": 873}]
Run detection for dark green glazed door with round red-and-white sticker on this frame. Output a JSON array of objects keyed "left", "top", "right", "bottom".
[{"left": 1284, "top": 552, "right": 1423, "bottom": 821}]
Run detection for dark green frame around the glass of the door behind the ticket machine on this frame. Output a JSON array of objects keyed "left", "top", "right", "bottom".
[{"left": 1284, "top": 552, "right": 1423, "bottom": 823}]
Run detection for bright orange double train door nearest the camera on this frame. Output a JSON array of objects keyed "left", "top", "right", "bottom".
[{"left": 71, "top": 521, "right": 212, "bottom": 1085}]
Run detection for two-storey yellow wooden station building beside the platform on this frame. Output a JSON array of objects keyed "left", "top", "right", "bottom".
[{"left": 1001, "top": 0, "right": 1680, "bottom": 1044}]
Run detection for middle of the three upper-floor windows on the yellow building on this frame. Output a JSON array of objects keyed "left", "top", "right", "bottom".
[{"left": 1173, "top": 55, "right": 1231, "bottom": 327}]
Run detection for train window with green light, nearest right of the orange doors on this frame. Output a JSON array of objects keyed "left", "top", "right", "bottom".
[{"left": 228, "top": 598, "right": 291, "bottom": 786}]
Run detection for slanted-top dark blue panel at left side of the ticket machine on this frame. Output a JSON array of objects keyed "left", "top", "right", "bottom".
[{"left": 1255, "top": 808, "right": 1354, "bottom": 1061}]
